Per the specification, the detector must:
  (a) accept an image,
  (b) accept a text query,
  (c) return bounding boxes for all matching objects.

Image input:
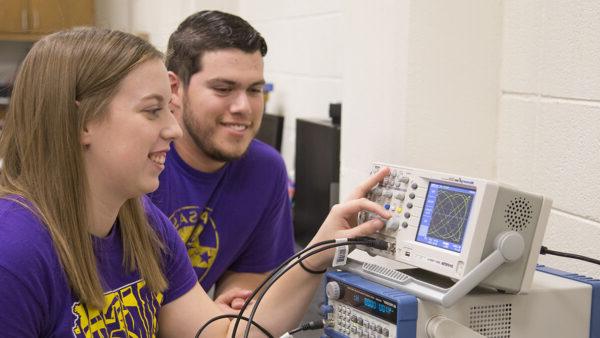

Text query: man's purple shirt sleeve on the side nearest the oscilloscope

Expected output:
[229,159,294,273]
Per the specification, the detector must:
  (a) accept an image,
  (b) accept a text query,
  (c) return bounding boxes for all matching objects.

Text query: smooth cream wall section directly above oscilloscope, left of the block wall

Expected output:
[341,0,502,195]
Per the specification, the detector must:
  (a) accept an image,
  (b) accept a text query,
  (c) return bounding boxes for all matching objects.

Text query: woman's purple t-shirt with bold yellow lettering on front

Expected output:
[0,198,196,337]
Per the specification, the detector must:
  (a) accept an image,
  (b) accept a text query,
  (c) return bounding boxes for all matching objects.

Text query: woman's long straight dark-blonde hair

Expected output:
[0,28,167,309]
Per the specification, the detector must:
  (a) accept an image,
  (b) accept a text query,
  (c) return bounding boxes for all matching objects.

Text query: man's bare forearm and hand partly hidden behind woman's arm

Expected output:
[215,271,270,313]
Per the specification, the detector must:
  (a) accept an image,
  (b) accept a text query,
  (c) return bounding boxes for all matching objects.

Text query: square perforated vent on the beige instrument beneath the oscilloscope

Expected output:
[469,303,512,338]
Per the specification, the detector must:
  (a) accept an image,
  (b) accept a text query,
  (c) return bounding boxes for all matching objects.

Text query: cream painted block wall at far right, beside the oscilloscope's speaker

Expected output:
[497,0,600,278]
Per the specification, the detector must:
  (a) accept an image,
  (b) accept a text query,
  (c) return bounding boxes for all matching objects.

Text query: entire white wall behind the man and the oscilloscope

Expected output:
[98,0,600,278]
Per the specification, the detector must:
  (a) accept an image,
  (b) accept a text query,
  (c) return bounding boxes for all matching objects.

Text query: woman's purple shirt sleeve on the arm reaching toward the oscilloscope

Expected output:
[144,199,198,305]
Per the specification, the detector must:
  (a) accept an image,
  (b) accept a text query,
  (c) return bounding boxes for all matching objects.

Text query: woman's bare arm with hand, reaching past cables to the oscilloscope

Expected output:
[159,168,391,338]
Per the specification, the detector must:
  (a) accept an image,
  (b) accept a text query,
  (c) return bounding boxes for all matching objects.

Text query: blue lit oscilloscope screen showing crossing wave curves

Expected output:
[416,182,475,252]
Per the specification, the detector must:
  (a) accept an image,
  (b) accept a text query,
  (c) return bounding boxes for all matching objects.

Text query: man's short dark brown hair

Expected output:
[166,11,267,86]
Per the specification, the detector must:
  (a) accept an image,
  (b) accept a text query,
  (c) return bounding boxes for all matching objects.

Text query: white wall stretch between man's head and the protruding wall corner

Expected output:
[240,0,346,173]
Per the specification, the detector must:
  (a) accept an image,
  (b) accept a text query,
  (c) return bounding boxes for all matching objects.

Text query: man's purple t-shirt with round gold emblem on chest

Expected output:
[150,140,294,290]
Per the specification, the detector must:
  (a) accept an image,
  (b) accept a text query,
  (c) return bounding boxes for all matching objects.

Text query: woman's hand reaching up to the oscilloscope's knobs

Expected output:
[304,167,392,270]
